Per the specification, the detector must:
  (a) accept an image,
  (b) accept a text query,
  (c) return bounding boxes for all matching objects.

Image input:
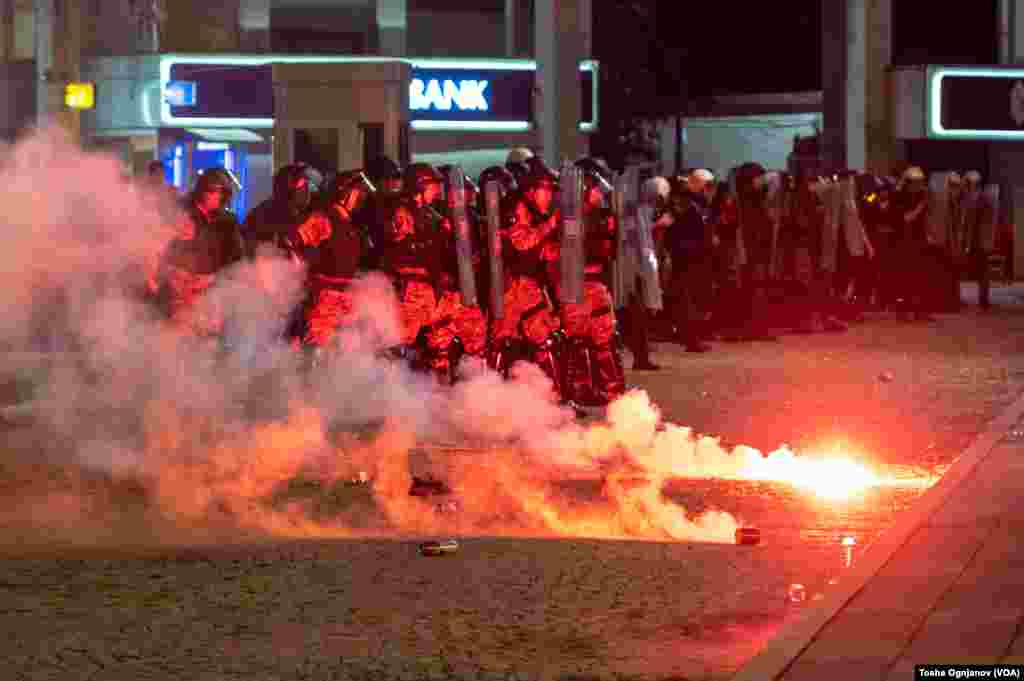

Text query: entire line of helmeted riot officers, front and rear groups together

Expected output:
[148,153,999,406]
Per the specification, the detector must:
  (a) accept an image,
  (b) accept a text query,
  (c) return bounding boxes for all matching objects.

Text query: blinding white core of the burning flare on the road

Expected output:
[741,449,883,501]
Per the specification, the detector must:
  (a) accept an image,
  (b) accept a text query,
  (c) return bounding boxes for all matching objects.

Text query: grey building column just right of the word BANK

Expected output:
[534,0,590,167]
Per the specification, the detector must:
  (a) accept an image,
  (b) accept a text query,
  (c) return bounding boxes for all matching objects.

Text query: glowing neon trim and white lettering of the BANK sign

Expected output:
[160,54,599,132]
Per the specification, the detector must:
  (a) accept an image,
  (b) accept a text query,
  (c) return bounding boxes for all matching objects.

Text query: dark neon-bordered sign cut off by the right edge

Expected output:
[926,66,1024,140]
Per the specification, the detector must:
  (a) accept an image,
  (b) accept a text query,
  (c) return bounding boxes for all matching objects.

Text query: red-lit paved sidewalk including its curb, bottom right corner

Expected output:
[733,387,1024,681]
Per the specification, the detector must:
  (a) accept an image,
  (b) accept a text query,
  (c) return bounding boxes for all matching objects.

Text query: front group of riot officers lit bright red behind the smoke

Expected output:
[147,148,647,407]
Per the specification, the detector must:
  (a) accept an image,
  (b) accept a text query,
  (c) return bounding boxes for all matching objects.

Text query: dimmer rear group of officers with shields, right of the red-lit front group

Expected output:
[629,163,999,352]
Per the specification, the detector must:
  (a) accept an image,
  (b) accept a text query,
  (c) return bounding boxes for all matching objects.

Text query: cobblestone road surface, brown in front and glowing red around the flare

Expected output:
[0,289,1024,681]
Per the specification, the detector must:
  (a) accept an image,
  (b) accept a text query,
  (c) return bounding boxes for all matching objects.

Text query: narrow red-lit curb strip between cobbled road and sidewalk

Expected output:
[731,387,1024,681]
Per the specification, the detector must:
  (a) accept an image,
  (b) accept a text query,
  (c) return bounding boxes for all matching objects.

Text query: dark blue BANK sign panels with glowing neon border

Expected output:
[161,55,598,132]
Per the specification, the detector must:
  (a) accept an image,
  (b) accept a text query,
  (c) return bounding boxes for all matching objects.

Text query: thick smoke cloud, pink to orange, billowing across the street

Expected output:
[0,129,753,541]
